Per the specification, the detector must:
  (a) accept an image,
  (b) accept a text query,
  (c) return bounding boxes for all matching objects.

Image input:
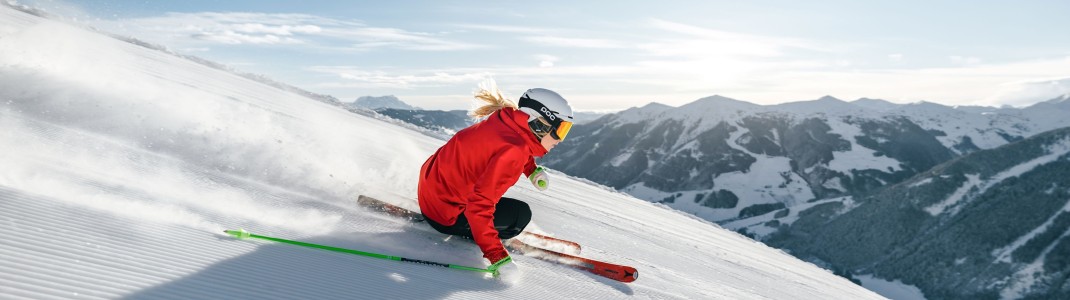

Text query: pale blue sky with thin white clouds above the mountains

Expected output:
[18,0,1070,111]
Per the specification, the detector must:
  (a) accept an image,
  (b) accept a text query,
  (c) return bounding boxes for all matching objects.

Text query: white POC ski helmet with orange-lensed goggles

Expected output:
[518,88,574,140]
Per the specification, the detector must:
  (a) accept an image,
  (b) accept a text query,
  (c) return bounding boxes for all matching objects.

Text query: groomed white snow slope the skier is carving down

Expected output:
[0,5,880,299]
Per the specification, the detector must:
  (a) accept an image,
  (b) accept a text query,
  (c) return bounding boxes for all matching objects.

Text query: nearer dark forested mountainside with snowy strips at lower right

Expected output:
[744,128,1070,299]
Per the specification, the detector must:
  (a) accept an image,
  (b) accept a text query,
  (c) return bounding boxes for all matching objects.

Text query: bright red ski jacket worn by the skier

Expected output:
[417,107,547,263]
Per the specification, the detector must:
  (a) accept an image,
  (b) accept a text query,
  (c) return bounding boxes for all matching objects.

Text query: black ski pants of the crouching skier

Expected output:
[424,197,532,240]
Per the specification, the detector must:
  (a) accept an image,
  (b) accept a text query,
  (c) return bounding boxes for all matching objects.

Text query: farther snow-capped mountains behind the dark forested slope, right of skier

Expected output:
[546,95,1070,222]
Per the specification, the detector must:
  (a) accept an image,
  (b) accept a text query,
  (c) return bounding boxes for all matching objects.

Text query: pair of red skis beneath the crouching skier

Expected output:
[357,195,639,283]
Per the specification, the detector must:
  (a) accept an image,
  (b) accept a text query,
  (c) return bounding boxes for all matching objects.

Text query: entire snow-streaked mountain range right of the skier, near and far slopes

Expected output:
[541,93,1070,299]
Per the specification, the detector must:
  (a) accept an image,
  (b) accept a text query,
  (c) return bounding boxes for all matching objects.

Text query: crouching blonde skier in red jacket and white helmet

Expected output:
[417,83,572,278]
